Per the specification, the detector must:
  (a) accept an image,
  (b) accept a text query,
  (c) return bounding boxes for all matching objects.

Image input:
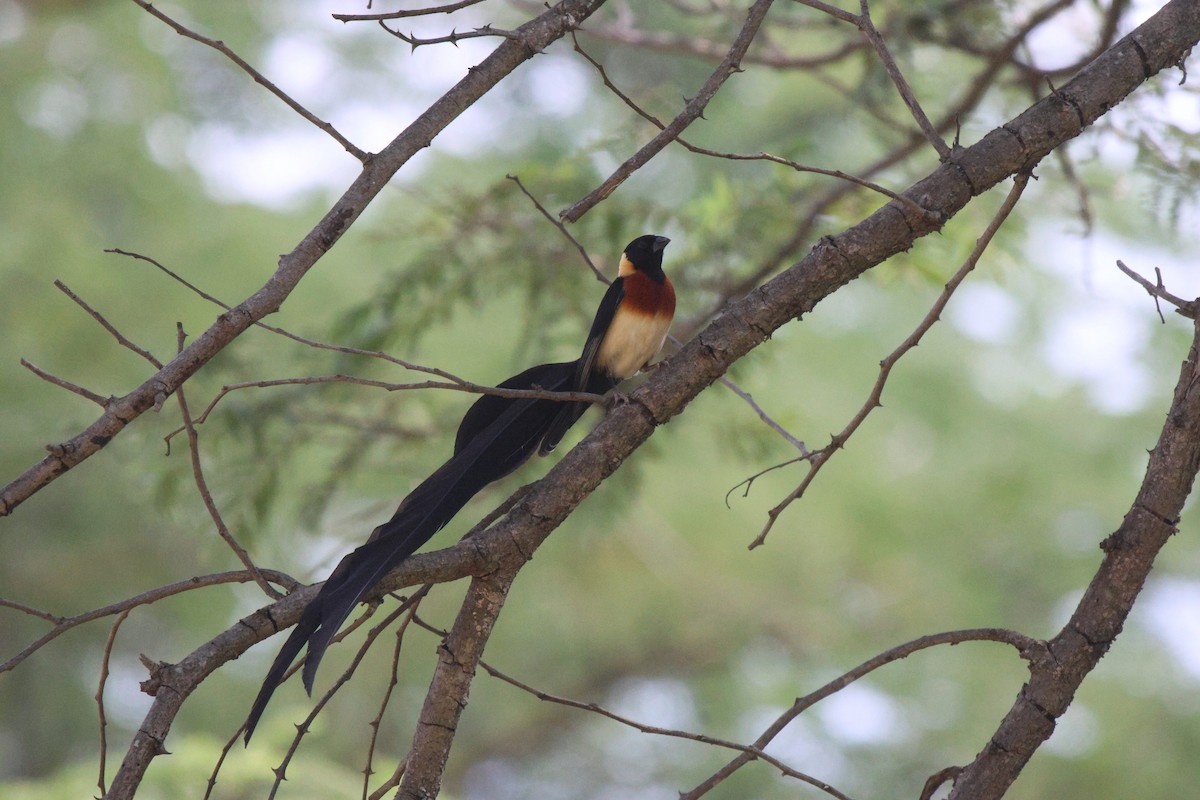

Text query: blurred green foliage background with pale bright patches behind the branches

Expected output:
[0,0,1200,800]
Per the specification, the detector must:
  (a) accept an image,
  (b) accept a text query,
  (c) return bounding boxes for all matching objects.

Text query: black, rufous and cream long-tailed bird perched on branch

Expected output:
[245,235,674,745]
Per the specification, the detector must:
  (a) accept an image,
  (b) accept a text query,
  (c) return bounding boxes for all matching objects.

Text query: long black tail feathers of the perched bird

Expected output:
[246,361,582,744]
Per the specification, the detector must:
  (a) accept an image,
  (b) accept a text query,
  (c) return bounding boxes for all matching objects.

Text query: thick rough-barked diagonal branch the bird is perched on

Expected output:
[87,7,1200,798]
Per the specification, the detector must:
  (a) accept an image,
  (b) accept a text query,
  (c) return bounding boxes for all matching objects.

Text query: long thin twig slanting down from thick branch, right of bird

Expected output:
[750,173,1030,549]
